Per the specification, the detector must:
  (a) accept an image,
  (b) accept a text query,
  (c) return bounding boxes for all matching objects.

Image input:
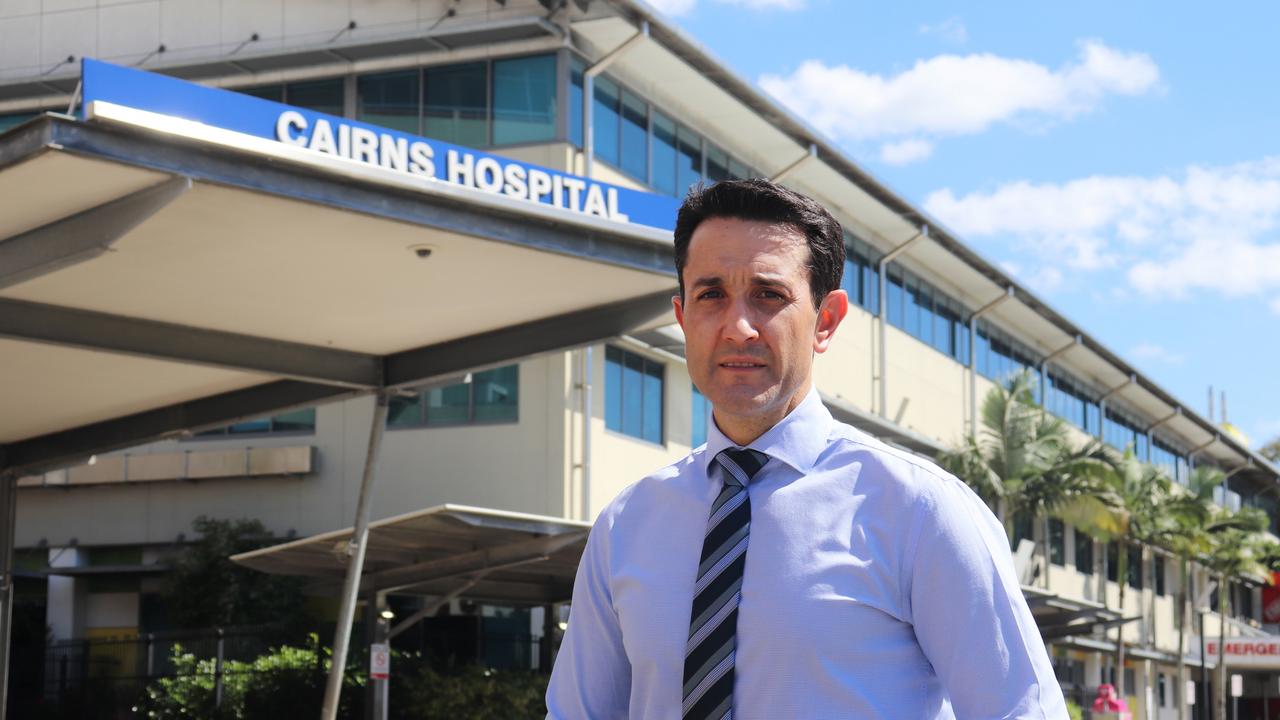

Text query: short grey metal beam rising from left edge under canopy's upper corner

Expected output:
[0,177,191,288]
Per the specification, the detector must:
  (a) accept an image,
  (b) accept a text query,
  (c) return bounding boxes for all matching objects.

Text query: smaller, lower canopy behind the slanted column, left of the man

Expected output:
[232,505,591,605]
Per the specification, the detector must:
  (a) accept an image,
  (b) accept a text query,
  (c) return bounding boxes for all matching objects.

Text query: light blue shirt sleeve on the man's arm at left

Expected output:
[547,510,631,720]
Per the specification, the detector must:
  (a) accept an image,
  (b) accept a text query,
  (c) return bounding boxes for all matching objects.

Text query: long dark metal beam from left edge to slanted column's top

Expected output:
[0,299,381,389]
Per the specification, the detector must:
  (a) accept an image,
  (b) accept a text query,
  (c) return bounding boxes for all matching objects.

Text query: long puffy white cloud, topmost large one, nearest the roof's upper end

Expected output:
[760,41,1160,140]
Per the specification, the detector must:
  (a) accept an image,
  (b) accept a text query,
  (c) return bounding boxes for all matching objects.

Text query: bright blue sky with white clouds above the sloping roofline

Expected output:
[649,0,1280,448]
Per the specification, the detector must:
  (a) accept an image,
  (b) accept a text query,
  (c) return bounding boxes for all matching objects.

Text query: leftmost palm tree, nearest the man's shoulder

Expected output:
[940,372,1107,543]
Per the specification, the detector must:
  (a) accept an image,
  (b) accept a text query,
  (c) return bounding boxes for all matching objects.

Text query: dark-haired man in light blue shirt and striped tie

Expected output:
[547,179,1066,720]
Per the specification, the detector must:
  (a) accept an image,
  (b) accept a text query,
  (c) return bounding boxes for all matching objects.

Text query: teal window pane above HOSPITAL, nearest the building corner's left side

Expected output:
[493,55,556,145]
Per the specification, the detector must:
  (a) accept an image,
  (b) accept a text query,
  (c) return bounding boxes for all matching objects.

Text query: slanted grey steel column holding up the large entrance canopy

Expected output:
[320,392,390,720]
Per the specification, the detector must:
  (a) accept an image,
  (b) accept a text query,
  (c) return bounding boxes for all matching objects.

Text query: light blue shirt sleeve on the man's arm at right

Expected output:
[906,478,1068,720]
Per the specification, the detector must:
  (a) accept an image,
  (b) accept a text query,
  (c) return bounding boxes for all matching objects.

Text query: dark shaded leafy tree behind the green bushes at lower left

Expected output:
[161,515,302,628]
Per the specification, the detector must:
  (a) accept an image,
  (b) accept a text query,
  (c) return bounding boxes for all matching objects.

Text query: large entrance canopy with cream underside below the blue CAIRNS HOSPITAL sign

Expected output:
[0,109,675,477]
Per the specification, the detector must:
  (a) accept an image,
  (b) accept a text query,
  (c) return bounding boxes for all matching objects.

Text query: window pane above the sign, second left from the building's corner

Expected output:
[422,63,489,147]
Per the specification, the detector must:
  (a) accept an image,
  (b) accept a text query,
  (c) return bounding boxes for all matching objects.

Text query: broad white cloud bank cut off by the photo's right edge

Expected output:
[925,156,1280,298]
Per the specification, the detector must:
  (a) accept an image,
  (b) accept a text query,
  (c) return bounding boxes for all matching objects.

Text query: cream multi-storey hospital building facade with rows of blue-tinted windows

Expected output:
[0,0,1280,717]
